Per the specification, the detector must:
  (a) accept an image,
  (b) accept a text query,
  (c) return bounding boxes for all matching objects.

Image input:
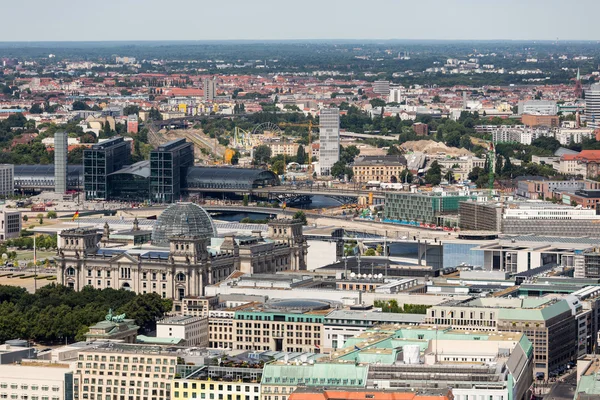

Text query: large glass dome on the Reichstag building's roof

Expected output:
[152,203,217,247]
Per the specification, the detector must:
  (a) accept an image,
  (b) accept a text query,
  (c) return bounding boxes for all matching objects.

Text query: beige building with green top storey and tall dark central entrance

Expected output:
[234,299,331,353]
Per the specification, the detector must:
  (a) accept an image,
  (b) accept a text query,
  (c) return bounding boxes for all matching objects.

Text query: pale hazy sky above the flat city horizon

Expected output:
[0,0,600,41]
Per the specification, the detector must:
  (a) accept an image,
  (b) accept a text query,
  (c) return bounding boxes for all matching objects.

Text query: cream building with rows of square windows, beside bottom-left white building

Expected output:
[72,343,177,400]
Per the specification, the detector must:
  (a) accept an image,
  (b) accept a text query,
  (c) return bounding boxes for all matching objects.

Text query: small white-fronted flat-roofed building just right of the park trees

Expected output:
[156,316,208,347]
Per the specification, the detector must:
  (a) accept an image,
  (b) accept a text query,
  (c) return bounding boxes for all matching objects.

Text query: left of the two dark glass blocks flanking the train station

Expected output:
[83,137,131,200]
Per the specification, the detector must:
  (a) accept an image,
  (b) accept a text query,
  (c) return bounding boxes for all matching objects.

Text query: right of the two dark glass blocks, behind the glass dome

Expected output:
[150,139,194,203]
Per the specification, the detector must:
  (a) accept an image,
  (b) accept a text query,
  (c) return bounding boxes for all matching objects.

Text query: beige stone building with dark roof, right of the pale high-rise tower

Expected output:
[352,156,406,183]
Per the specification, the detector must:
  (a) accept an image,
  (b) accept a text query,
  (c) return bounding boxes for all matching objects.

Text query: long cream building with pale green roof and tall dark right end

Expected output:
[425,298,578,376]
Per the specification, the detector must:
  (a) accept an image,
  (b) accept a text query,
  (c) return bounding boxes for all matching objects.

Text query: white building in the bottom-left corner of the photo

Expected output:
[0,361,73,400]
